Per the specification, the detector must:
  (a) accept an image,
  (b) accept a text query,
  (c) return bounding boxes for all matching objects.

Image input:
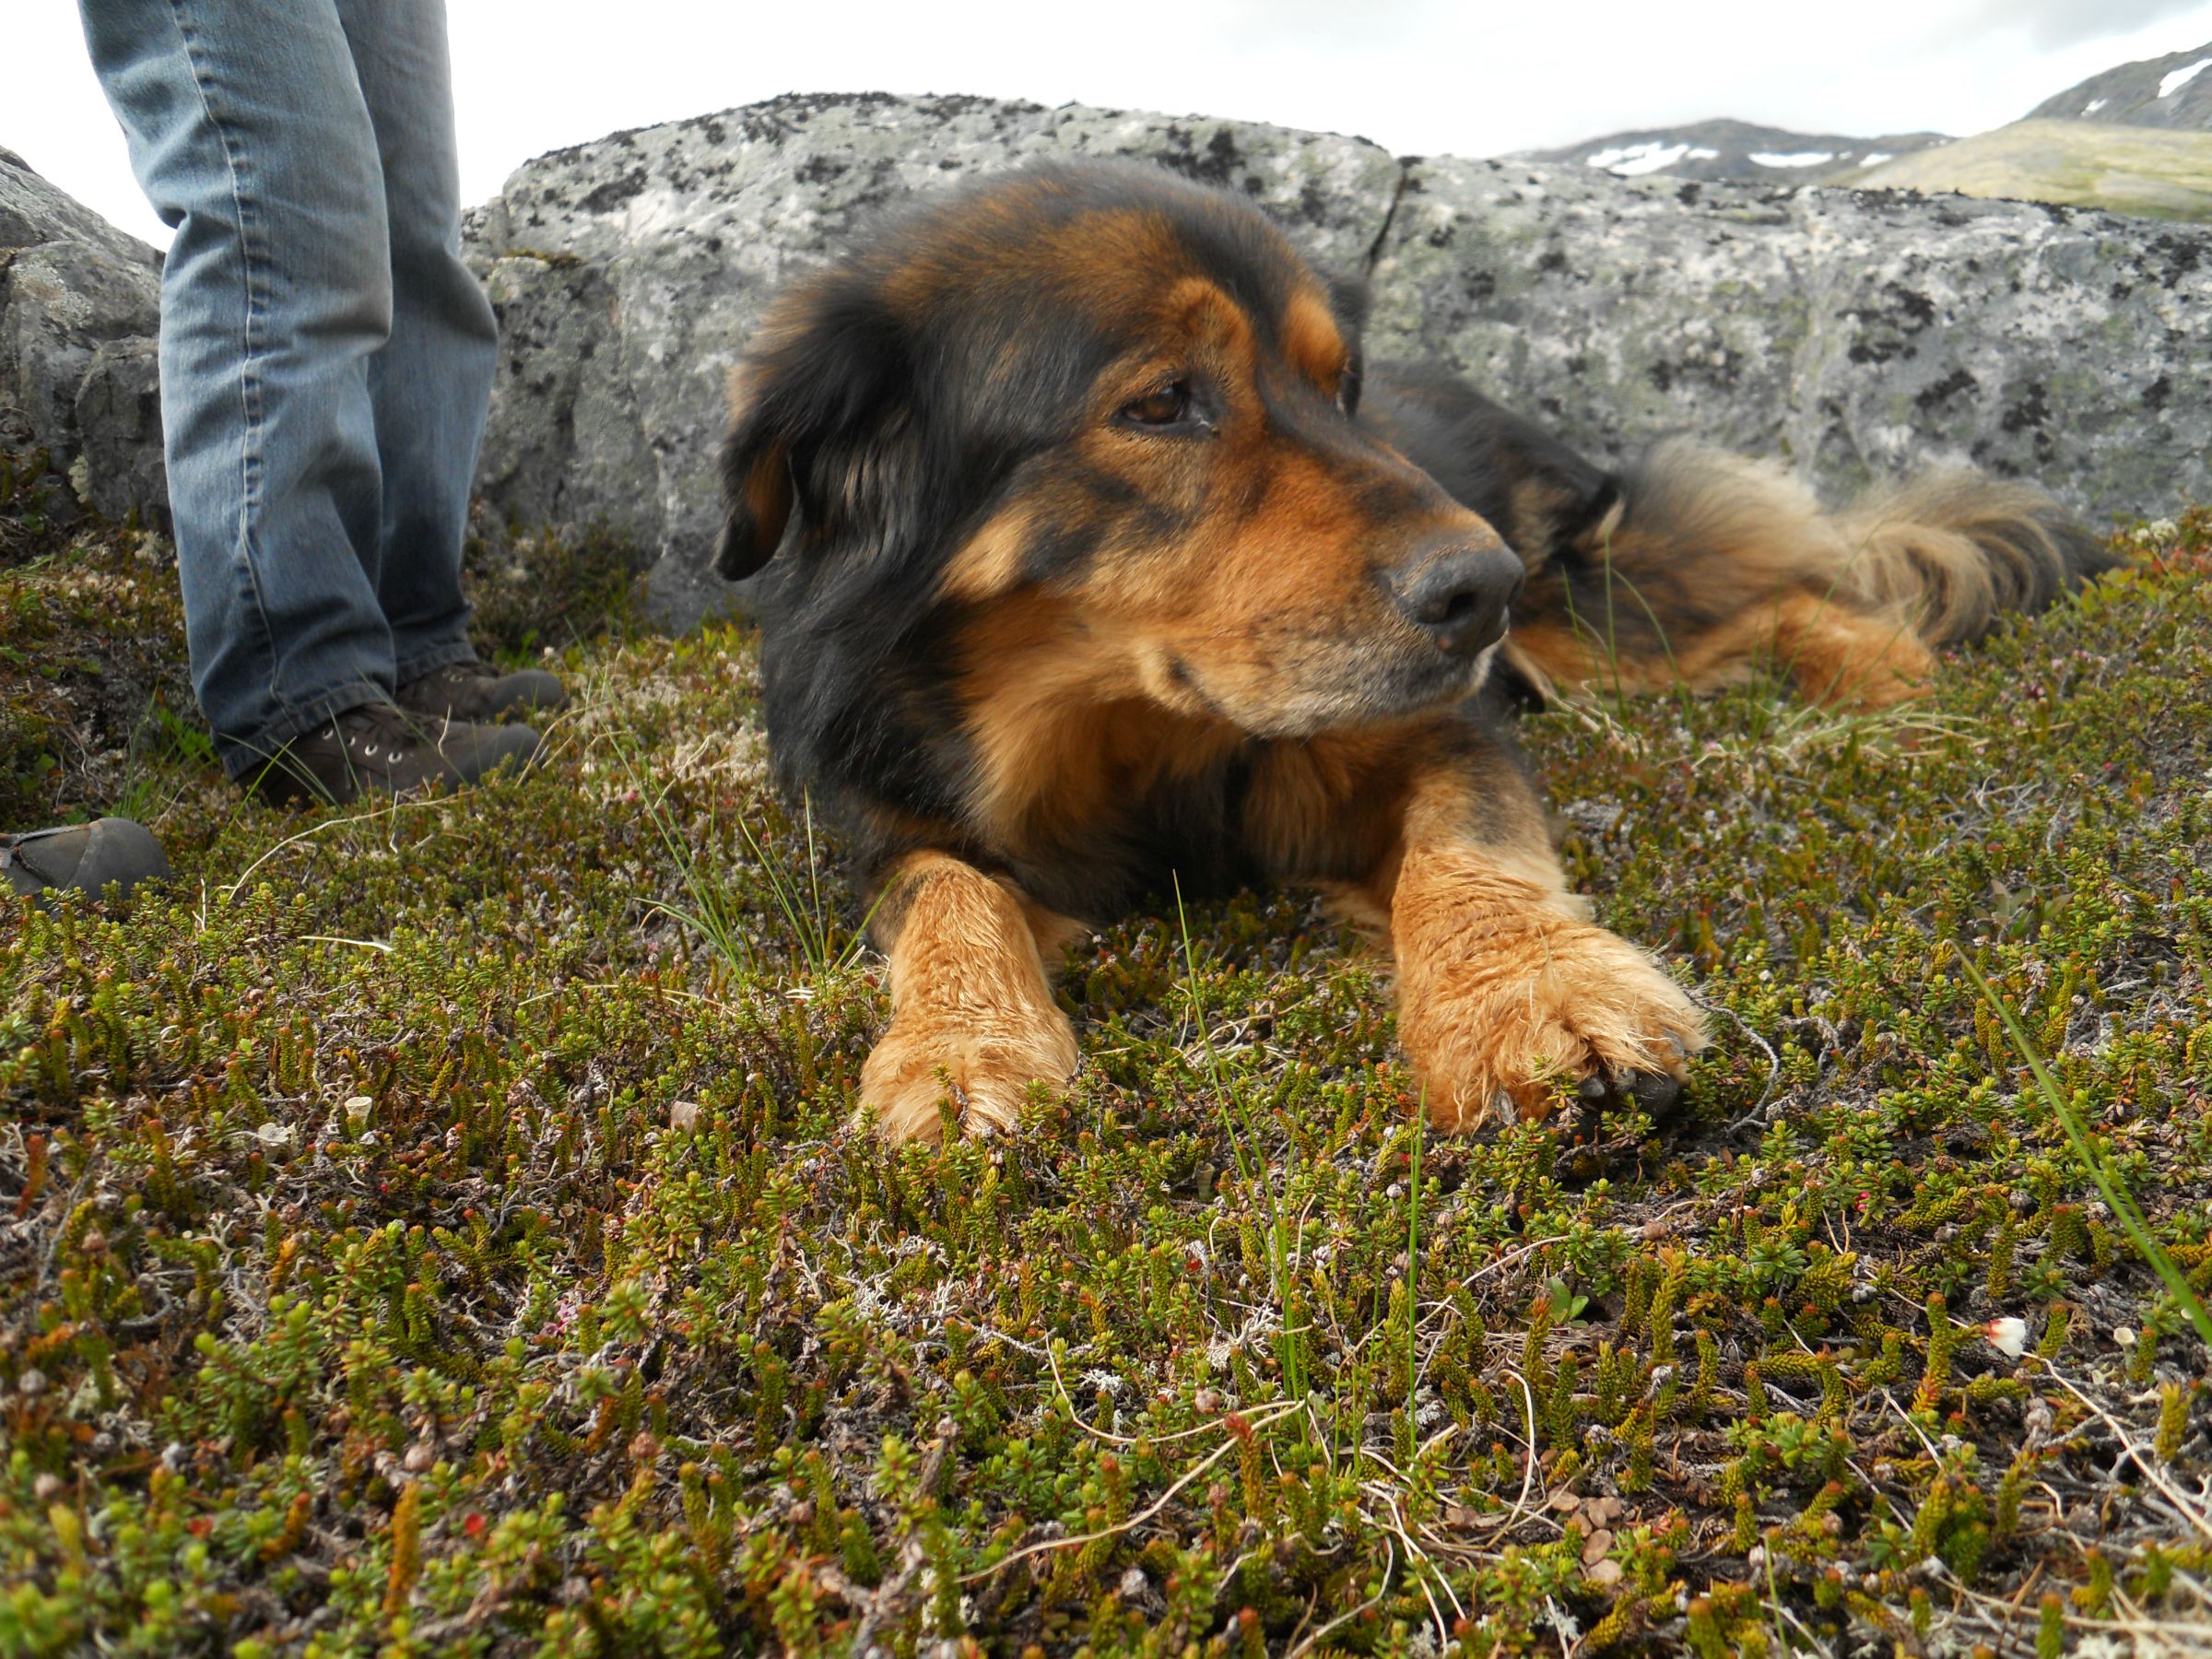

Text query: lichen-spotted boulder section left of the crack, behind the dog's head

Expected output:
[466,95,1400,626]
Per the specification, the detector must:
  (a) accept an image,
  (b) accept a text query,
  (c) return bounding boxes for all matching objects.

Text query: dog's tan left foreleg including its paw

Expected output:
[861,852,1075,1144]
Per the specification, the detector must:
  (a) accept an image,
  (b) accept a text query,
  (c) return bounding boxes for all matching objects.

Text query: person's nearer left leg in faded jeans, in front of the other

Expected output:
[82,0,394,776]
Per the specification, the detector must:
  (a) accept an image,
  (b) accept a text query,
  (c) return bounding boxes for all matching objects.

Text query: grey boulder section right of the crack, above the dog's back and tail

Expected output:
[1373,159,2212,515]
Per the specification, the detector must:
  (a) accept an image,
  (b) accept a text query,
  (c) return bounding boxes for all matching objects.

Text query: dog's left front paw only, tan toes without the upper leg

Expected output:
[861,1011,1075,1146]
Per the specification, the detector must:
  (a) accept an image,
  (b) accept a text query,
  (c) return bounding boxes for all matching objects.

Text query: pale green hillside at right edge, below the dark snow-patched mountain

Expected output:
[1856,120,2212,221]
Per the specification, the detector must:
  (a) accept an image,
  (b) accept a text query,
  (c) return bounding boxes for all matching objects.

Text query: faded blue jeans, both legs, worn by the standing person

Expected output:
[82,0,498,776]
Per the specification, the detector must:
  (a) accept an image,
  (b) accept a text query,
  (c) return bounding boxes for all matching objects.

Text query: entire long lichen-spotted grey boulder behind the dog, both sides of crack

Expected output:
[469,95,2212,626]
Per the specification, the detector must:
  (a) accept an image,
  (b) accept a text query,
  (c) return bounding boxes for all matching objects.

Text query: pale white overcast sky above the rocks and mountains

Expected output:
[13,0,2212,239]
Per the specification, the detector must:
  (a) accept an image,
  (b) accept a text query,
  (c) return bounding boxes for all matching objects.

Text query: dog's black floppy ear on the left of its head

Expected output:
[714,285,931,582]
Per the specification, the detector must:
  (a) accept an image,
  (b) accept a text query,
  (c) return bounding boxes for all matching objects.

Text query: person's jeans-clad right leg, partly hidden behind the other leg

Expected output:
[336,0,500,686]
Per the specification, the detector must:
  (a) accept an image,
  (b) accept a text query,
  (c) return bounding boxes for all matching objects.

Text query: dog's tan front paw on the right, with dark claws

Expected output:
[1398,918,1705,1130]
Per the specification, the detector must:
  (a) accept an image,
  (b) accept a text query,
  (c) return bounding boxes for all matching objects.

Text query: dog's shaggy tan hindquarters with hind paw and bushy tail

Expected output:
[1509,441,2112,706]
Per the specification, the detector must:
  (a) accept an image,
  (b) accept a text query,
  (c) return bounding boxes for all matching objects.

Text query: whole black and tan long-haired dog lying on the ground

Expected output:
[719,164,2097,1139]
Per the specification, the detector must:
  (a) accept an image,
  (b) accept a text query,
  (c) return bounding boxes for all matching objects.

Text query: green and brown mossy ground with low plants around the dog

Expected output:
[0,471,2212,1659]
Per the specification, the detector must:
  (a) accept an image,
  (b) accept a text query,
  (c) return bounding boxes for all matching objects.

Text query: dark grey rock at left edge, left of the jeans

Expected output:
[0,150,168,518]
